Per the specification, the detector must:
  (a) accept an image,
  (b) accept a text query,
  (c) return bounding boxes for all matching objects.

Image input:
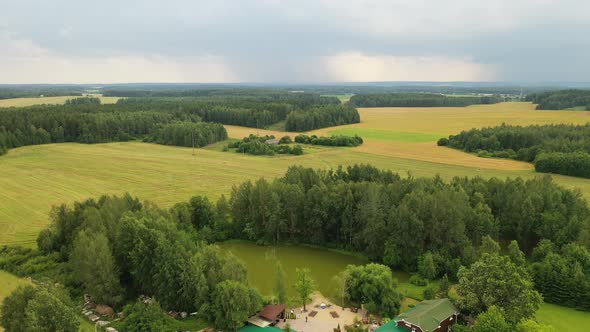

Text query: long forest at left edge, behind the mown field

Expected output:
[0,104,208,155]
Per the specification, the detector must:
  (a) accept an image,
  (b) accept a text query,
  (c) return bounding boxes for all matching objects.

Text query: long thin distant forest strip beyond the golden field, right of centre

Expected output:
[349,93,504,107]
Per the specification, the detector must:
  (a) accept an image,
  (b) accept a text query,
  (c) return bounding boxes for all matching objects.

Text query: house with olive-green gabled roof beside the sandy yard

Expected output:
[375,299,459,332]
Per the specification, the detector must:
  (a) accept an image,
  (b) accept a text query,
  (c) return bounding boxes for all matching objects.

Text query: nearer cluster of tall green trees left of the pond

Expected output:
[0,195,262,331]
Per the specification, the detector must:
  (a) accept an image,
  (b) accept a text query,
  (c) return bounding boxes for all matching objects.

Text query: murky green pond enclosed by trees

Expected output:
[218,241,368,298]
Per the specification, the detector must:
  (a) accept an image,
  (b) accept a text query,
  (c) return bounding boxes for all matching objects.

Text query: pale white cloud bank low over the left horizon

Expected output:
[0,34,238,83]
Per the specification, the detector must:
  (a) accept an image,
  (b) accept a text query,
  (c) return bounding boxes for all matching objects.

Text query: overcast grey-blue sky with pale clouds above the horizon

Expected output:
[0,0,590,83]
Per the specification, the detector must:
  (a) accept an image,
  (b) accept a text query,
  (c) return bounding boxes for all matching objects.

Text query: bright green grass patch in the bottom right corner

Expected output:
[537,303,590,332]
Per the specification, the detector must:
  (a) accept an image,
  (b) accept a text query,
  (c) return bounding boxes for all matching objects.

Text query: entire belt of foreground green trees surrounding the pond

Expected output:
[0,165,590,330]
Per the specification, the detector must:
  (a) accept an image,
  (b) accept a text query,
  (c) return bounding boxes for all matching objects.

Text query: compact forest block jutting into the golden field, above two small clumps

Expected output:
[285,105,361,132]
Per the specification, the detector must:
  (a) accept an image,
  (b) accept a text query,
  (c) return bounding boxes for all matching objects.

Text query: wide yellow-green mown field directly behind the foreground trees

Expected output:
[0,142,590,246]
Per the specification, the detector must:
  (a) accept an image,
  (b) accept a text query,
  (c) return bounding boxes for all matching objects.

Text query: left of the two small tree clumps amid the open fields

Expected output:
[227,134,303,156]
